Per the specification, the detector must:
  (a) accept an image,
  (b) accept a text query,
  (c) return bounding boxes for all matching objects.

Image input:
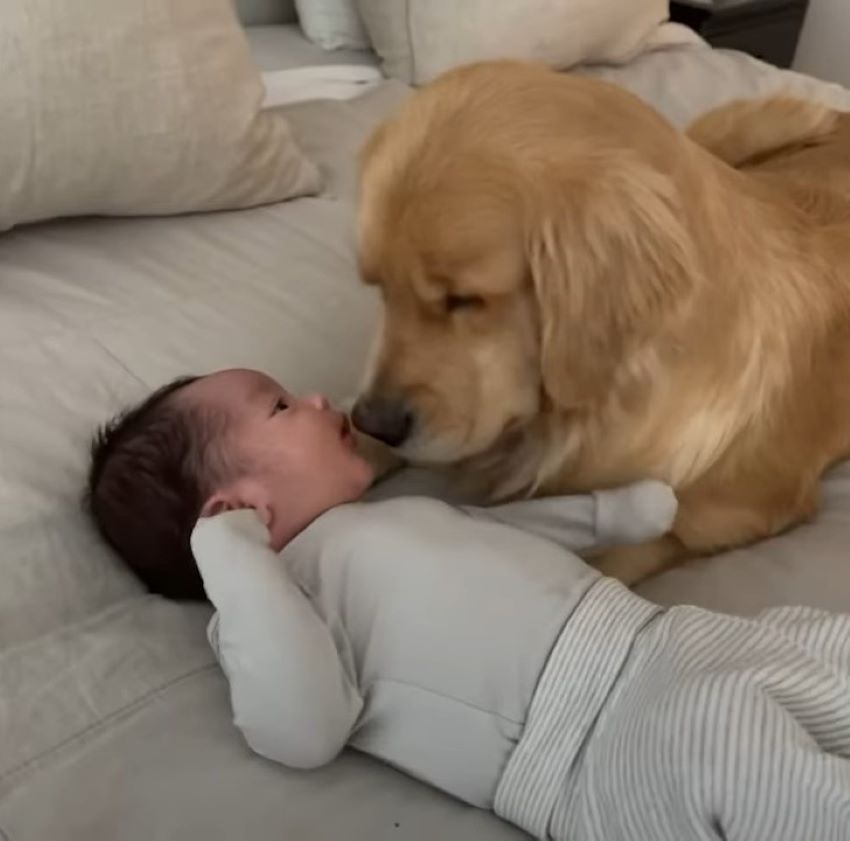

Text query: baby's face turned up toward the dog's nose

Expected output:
[184,368,373,549]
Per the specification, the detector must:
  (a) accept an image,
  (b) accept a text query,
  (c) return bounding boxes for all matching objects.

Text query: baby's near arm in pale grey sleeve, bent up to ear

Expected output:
[192,510,363,768]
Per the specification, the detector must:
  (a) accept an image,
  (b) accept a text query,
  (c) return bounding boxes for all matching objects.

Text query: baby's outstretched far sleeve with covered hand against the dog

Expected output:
[463,480,678,552]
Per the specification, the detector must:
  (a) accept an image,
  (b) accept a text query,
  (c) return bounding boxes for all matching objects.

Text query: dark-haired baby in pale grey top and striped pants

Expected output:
[89,370,850,841]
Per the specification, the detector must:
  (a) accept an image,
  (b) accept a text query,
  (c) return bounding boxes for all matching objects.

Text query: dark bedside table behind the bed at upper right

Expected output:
[670,0,809,67]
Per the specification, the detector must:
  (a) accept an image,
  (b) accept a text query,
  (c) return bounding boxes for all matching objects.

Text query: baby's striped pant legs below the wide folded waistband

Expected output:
[554,608,850,841]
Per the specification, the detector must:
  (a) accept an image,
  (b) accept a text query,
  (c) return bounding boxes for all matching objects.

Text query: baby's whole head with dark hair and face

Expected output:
[88,369,372,599]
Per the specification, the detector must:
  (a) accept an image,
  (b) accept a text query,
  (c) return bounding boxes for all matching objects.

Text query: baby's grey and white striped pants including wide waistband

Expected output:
[497,581,850,841]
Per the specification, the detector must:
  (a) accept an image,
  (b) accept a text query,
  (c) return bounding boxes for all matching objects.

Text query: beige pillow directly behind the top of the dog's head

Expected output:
[358,0,668,84]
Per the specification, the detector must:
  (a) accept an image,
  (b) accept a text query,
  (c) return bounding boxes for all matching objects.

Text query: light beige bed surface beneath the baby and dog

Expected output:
[0,28,850,841]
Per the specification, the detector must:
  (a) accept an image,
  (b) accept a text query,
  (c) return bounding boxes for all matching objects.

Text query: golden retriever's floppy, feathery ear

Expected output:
[525,155,699,409]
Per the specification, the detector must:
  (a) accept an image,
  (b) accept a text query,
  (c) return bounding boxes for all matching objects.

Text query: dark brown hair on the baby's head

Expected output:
[86,377,226,600]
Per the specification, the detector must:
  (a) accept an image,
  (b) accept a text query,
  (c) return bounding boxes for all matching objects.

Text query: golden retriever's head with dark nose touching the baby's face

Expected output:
[355,62,696,486]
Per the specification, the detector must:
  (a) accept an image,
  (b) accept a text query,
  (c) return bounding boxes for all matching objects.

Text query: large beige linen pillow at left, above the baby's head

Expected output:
[0,0,320,230]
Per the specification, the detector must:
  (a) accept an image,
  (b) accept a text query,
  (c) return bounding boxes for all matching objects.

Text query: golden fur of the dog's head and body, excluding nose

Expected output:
[359,62,850,583]
